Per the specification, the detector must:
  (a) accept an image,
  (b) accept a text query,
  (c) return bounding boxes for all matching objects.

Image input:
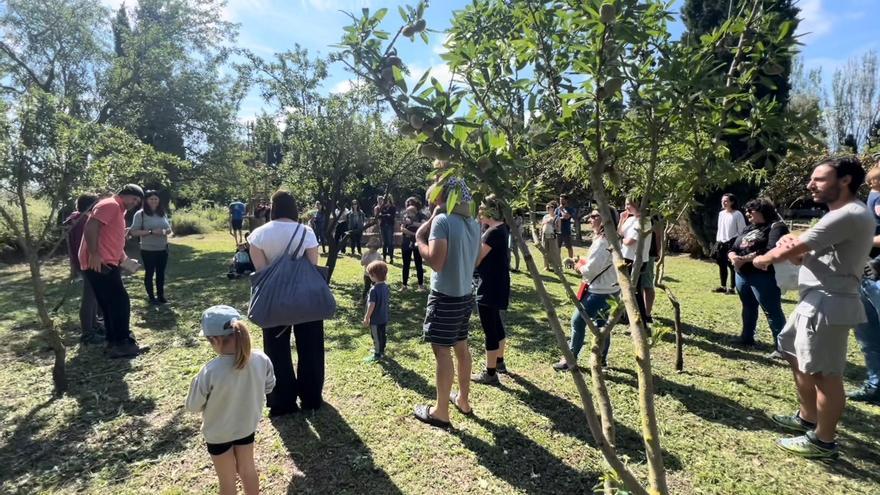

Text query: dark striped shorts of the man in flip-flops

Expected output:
[422,290,474,347]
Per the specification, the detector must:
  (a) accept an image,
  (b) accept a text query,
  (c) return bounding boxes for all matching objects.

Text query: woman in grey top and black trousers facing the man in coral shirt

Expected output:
[129,190,171,304]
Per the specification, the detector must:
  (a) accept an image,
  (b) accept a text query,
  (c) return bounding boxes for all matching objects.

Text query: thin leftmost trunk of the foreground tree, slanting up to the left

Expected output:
[504,208,648,495]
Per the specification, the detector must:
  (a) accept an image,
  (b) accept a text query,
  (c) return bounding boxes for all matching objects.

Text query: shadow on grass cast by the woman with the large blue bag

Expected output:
[272,402,403,495]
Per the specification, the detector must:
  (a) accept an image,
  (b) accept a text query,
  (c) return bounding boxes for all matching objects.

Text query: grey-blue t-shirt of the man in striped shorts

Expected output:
[428,213,480,297]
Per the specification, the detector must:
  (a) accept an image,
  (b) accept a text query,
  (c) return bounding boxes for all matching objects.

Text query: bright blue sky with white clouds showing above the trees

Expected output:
[104,0,880,120]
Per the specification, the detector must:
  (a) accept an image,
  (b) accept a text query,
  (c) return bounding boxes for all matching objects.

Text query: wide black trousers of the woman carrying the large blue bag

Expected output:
[263,321,324,412]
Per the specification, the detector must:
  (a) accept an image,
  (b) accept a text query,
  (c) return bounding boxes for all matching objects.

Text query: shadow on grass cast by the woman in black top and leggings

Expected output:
[508,374,682,471]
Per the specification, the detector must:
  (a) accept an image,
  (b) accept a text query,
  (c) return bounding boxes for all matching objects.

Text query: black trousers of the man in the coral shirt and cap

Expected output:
[83,267,134,345]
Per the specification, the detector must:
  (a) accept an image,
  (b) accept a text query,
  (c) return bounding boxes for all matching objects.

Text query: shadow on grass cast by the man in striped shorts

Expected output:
[453,416,600,493]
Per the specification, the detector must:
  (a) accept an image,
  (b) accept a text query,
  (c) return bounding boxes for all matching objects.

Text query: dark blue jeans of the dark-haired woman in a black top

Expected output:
[736,272,785,348]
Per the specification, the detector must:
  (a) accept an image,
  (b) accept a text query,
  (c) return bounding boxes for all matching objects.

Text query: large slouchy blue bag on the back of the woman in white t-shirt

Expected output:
[248,224,336,328]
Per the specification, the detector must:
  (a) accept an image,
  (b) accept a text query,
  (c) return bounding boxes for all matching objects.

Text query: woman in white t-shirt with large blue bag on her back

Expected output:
[248,191,336,417]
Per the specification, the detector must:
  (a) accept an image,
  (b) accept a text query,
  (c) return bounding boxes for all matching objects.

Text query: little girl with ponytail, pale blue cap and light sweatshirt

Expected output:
[186,305,275,495]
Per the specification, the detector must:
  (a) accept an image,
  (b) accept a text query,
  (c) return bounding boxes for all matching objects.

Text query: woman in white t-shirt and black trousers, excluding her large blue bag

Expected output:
[248,191,324,417]
